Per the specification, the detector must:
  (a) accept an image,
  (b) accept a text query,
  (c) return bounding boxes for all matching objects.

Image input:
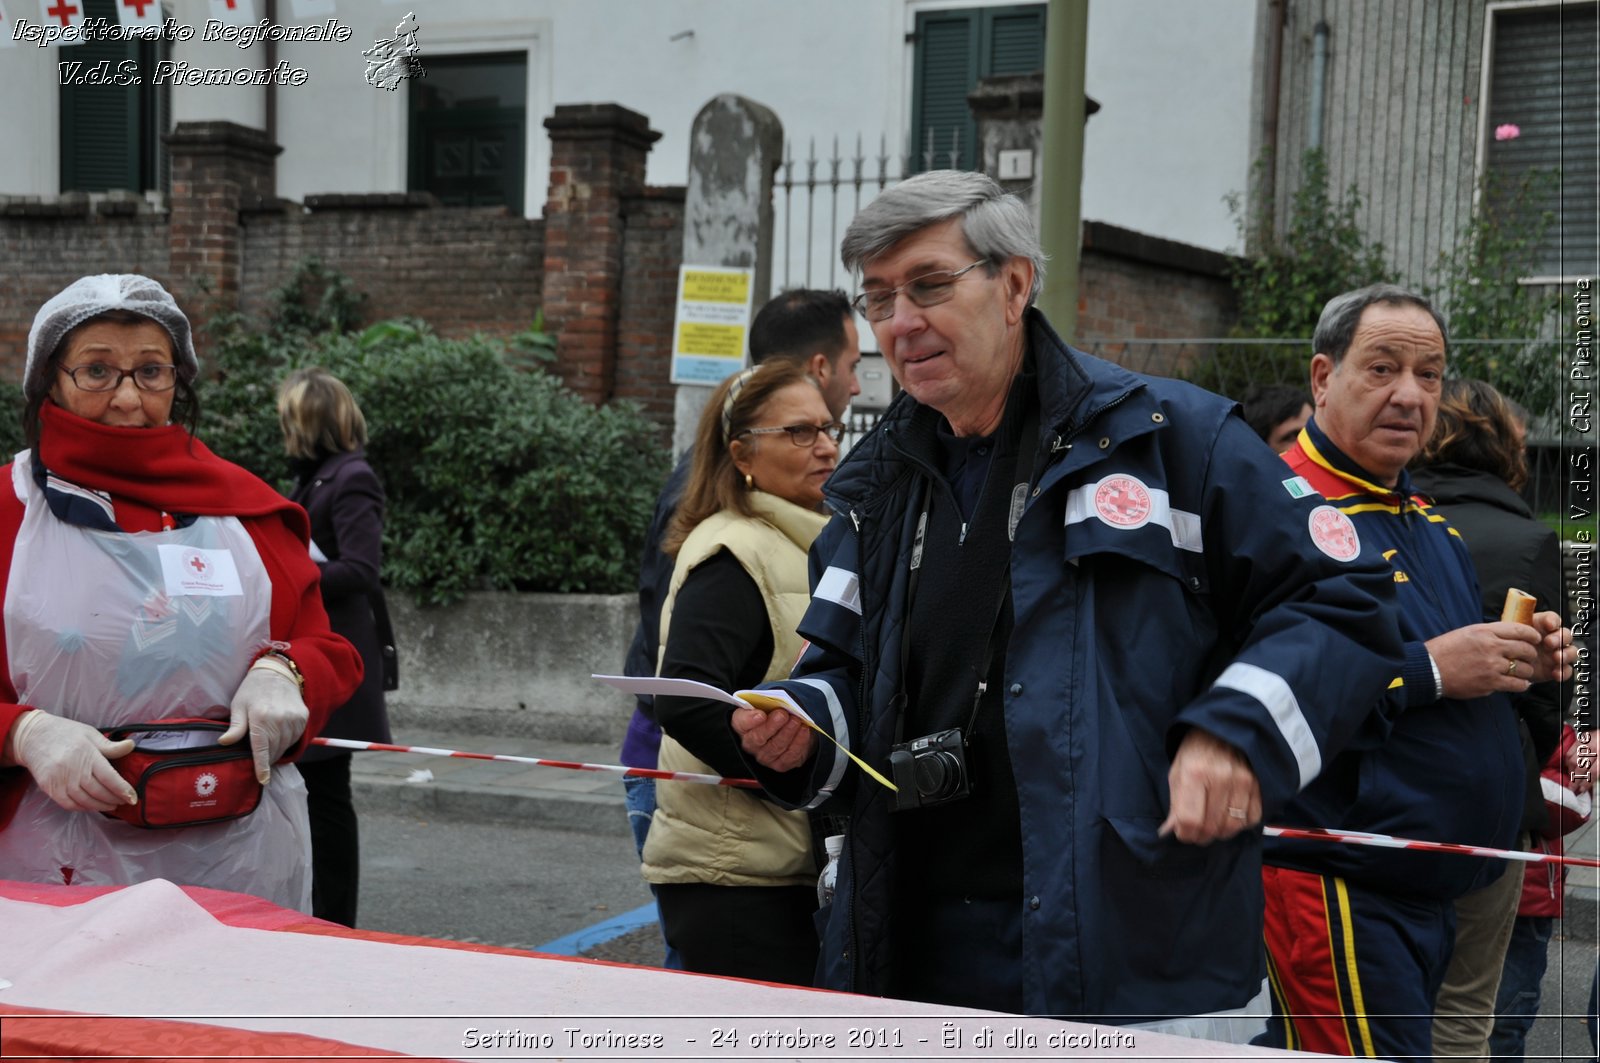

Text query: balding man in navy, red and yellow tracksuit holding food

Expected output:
[1262,285,1576,1058]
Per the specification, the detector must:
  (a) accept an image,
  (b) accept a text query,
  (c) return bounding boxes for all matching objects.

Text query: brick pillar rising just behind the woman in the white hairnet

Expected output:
[165,122,283,317]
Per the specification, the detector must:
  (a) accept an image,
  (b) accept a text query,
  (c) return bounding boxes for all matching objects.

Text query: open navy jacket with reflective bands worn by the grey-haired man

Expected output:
[752,311,1400,1021]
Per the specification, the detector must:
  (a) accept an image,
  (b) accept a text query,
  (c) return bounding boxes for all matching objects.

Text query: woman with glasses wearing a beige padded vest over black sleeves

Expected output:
[643,362,843,985]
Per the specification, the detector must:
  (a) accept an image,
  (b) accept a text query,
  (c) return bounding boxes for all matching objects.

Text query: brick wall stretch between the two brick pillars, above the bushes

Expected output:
[240,194,544,336]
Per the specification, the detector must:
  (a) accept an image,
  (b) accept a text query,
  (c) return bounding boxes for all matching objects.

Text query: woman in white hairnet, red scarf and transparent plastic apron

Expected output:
[0,274,362,911]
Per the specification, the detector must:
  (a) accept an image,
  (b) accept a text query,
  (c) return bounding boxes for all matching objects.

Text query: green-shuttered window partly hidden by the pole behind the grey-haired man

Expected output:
[910,3,1045,171]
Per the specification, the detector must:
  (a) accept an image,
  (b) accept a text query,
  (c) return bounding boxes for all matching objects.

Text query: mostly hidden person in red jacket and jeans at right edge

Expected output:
[1490,725,1594,1060]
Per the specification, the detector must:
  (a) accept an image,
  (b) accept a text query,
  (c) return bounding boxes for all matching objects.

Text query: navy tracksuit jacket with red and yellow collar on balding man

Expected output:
[1267,418,1523,900]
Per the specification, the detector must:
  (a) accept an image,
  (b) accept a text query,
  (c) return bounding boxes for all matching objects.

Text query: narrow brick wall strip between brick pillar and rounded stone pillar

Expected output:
[613,187,683,434]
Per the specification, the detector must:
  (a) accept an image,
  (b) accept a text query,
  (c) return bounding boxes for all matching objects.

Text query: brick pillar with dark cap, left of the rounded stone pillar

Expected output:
[544,104,661,403]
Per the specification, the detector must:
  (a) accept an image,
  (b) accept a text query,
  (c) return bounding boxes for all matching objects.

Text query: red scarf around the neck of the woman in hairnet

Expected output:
[38,400,310,540]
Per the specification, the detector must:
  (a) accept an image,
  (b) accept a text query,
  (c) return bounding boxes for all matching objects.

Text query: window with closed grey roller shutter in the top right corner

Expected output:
[1482,3,1600,277]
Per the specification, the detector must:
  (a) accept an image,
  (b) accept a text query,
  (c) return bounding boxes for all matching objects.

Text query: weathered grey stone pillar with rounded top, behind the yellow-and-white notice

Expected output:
[672,93,784,455]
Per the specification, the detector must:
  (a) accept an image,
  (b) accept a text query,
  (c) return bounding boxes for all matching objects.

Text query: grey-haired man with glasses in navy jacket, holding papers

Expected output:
[733,171,1400,1041]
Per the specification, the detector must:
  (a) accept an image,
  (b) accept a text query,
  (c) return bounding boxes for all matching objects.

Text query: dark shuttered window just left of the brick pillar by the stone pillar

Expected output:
[410,51,528,215]
